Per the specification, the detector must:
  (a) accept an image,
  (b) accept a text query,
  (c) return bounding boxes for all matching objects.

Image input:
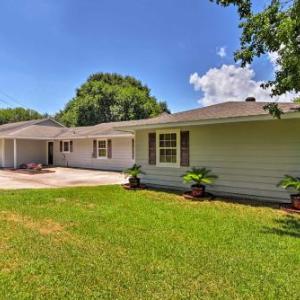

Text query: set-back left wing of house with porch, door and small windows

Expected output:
[0,119,134,171]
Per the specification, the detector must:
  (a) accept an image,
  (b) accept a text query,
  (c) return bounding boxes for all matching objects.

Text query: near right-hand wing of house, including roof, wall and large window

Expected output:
[117,101,300,202]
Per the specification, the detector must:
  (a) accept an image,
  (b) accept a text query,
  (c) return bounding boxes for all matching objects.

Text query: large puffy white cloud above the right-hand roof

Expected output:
[190,65,296,106]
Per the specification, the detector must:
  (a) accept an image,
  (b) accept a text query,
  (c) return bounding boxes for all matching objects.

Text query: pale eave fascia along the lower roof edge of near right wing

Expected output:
[114,111,300,132]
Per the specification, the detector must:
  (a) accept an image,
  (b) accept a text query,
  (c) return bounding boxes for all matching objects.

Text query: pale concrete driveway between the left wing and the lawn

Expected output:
[0,167,126,189]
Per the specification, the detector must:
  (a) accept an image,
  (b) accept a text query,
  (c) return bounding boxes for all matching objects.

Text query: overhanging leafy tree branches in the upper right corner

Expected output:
[210,0,300,95]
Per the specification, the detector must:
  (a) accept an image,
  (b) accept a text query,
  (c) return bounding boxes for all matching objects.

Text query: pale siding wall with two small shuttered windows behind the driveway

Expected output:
[54,137,134,171]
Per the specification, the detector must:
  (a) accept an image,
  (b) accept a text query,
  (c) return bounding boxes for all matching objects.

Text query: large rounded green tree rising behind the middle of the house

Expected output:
[56,73,168,126]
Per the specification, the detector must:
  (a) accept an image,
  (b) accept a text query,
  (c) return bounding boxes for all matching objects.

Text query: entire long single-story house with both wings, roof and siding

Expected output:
[0,102,300,202]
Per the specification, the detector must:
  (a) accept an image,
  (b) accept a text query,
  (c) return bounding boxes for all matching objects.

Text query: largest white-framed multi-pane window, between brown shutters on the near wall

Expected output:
[157,131,180,166]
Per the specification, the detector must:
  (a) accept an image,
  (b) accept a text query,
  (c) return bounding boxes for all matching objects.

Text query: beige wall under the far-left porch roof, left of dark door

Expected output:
[17,139,47,167]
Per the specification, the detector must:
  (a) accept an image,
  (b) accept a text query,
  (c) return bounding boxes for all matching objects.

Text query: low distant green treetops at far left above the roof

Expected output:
[0,107,46,125]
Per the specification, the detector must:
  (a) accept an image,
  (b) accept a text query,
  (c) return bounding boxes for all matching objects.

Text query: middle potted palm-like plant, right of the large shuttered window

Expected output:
[183,168,218,198]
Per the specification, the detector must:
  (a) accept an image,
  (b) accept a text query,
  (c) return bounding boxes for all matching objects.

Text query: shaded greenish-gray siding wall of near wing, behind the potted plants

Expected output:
[136,120,300,202]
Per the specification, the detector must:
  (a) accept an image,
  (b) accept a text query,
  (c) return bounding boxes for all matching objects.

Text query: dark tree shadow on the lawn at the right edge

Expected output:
[263,215,300,238]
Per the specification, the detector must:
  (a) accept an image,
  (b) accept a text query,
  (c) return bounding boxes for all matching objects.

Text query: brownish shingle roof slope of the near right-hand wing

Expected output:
[113,102,300,129]
